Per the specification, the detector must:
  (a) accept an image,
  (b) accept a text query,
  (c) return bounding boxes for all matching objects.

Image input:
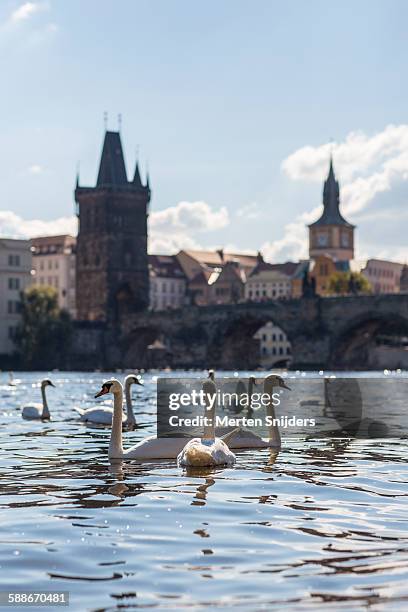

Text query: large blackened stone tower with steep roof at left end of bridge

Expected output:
[75,131,150,323]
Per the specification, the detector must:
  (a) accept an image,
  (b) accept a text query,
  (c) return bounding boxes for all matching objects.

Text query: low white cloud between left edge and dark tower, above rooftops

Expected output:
[0,210,77,238]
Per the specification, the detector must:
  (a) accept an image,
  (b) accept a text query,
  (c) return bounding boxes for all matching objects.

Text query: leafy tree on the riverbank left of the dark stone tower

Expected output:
[15,287,72,370]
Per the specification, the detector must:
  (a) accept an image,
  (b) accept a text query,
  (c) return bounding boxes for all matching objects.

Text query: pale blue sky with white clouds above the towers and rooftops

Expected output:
[0,0,408,261]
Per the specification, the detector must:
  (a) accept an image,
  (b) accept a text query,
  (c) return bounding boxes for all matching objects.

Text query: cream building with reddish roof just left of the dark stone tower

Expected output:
[31,234,76,319]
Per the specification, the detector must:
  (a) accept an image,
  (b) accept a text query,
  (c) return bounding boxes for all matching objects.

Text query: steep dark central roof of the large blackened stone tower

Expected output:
[96,131,127,187]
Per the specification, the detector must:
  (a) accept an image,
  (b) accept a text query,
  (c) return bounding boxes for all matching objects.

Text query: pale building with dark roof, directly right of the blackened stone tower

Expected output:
[149,255,187,310]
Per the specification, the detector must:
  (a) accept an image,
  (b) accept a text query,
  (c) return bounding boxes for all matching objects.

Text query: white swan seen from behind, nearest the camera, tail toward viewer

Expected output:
[177,371,236,467]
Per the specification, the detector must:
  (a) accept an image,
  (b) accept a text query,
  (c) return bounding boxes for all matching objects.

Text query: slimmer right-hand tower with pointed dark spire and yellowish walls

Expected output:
[309,158,355,261]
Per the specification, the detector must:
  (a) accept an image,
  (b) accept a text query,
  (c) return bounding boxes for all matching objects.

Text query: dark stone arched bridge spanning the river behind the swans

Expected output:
[115,294,408,370]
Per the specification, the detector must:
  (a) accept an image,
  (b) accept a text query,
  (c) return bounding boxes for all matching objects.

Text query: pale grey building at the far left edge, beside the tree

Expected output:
[0,238,32,355]
